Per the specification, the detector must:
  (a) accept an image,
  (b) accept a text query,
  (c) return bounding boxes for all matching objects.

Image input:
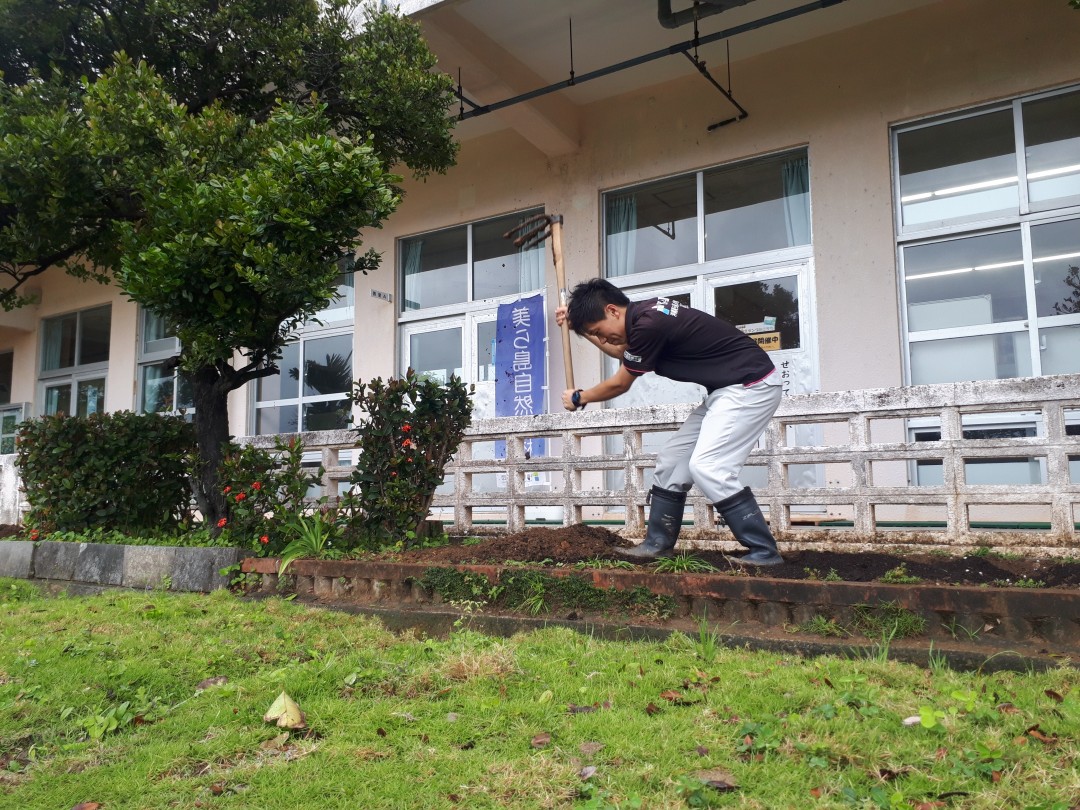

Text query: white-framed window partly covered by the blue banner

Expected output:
[397,208,546,416]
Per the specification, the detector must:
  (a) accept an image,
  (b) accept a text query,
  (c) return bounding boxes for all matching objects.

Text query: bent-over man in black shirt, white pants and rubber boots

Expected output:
[555,279,784,566]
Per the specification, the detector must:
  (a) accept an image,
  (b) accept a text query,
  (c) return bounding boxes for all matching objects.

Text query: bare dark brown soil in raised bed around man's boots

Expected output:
[393,524,1080,588]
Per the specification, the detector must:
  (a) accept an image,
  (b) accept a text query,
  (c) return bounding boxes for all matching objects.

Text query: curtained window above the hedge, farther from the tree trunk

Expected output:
[39,306,112,416]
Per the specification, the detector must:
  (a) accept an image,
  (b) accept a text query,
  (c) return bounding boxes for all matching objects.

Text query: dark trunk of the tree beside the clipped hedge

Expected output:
[191,367,230,527]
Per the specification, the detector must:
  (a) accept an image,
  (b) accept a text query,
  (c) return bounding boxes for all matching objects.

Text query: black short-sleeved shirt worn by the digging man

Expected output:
[622,298,775,392]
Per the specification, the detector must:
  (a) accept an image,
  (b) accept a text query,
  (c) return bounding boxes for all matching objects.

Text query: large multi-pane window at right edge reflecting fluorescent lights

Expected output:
[894,90,1080,384]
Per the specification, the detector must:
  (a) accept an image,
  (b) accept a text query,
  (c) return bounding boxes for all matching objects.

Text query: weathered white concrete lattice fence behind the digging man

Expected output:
[0,375,1080,555]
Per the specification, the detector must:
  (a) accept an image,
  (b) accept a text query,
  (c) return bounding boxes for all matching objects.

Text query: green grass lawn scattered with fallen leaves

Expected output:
[0,580,1080,810]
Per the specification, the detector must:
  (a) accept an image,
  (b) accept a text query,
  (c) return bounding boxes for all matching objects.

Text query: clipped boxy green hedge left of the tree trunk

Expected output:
[15,410,195,534]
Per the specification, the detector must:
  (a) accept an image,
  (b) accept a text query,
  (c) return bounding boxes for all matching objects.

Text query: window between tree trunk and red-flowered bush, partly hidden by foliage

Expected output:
[255,273,354,434]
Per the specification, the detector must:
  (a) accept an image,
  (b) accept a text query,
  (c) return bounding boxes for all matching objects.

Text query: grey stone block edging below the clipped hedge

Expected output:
[0,540,243,592]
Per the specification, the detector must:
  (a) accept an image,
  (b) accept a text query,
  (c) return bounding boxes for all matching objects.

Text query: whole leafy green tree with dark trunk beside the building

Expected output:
[0,0,456,522]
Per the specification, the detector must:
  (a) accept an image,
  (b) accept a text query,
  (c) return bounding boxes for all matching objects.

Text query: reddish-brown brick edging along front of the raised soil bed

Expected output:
[241,557,1080,659]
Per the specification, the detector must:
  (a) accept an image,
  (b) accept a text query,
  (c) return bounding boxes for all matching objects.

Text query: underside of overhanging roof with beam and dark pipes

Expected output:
[401,0,942,156]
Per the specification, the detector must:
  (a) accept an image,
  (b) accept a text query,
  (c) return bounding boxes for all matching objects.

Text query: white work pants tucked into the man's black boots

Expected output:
[652,372,783,503]
